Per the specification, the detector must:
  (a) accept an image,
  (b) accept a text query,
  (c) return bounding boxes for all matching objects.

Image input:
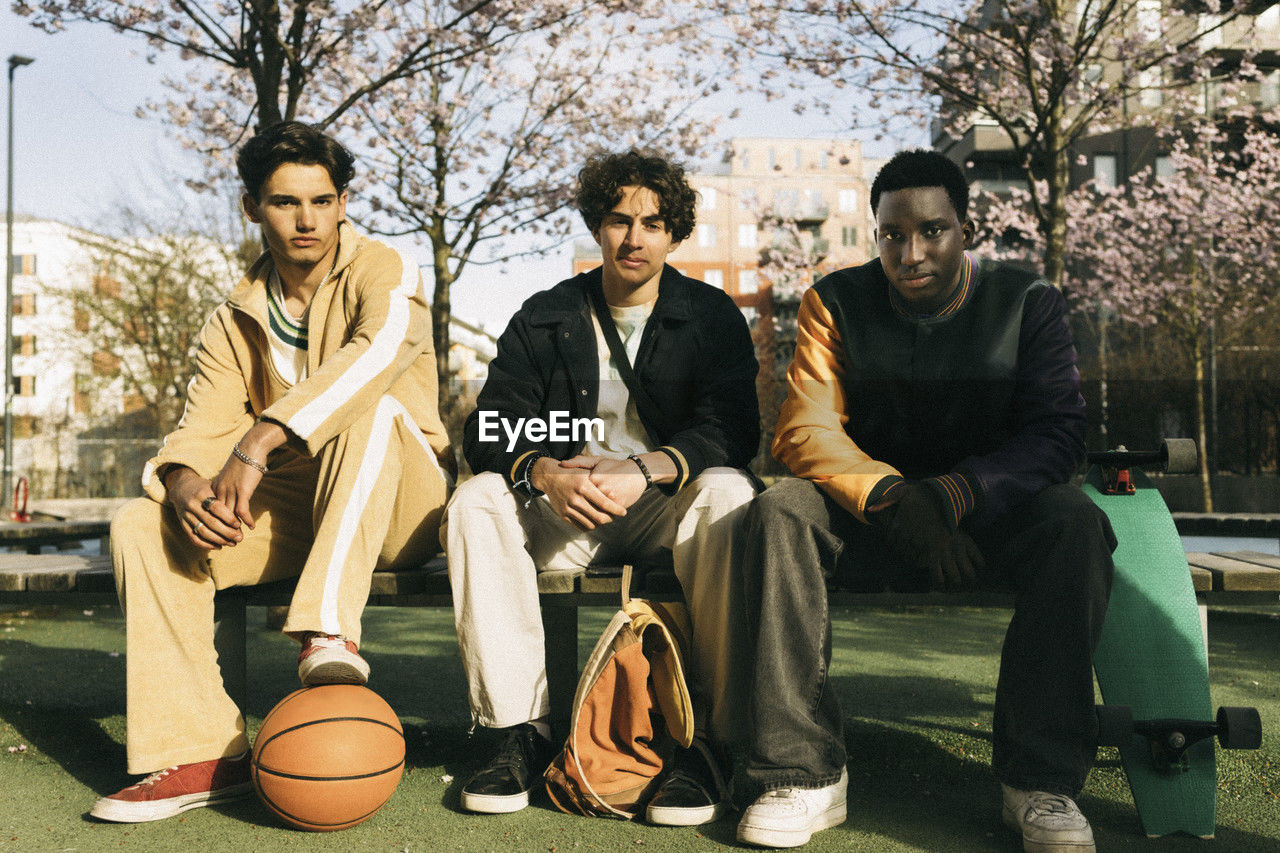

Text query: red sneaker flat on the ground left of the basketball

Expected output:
[90,752,253,824]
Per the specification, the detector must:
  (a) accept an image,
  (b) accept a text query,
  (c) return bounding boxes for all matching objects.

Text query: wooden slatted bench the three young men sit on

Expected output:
[0,529,1280,724]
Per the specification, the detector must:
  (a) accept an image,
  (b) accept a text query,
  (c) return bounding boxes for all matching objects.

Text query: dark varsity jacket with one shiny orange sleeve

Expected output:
[773,252,1085,525]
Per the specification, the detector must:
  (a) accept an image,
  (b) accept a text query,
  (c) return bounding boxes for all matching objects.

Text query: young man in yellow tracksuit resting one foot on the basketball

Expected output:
[92,122,452,822]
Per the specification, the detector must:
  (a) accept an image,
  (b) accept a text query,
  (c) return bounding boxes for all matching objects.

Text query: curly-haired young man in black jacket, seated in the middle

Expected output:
[444,151,759,825]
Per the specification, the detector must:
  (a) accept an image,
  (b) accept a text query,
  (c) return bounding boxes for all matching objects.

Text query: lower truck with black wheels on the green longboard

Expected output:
[1097,704,1262,774]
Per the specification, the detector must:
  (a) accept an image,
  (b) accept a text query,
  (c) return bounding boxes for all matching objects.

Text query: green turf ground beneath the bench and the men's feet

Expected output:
[0,607,1280,853]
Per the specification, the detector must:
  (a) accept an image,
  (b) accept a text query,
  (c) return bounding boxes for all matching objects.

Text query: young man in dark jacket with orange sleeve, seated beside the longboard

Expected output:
[737,151,1115,853]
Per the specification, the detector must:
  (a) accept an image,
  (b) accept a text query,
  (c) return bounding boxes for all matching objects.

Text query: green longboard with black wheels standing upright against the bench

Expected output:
[1084,439,1261,838]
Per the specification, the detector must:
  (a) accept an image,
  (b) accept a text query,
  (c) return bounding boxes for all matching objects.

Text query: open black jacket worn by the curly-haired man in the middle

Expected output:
[462,266,760,491]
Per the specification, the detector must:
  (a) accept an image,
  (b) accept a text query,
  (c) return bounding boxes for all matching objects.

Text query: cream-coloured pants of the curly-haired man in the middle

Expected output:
[443,467,755,742]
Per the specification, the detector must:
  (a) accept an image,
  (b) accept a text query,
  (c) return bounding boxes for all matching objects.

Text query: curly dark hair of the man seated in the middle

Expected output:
[573,149,698,242]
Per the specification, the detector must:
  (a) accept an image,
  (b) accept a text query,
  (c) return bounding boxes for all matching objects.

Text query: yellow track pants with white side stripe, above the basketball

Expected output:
[111,397,448,774]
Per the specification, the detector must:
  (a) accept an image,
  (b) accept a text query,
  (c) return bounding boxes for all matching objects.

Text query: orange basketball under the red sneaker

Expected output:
[252,684,404,833]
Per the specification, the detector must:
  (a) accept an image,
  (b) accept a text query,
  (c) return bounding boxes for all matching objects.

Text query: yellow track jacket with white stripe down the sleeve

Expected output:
[142,223,454,502]
